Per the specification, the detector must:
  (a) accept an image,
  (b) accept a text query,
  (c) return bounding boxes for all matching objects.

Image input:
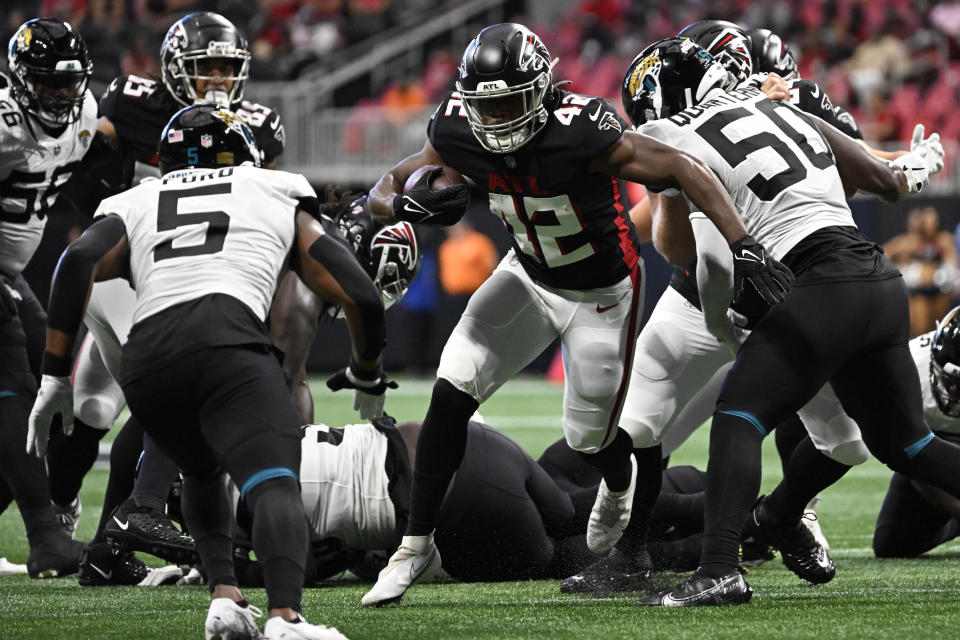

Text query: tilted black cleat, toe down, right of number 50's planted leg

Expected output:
[750,496,837,584]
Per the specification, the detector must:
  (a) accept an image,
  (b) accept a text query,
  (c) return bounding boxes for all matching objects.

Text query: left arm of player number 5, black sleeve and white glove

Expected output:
[27,216,130,458]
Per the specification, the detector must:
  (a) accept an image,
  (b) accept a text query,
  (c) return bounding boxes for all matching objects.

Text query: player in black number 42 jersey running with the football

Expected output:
[363,23,790,605]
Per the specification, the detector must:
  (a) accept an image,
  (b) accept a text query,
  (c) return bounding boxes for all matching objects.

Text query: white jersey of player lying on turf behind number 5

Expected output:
[300,424,397,550]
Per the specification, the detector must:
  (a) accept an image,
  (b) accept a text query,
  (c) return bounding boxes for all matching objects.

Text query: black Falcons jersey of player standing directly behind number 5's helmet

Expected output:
[100,76,285,187]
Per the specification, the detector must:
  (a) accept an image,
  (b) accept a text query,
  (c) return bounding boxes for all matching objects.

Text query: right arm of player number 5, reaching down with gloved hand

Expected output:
[292,211,396,419]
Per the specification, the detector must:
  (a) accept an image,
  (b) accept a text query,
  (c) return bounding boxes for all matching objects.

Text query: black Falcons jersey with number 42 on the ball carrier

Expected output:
[427,91,639,290]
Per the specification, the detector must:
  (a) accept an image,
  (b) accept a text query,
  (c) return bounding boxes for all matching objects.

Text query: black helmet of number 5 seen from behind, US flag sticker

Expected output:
[157,103,260,174]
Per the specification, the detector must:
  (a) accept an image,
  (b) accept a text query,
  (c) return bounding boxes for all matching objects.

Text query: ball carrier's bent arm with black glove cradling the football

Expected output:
[367,140,468,226]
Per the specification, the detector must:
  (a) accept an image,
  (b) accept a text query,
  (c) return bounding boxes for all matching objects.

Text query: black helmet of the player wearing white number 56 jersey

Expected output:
[7,18,93,127]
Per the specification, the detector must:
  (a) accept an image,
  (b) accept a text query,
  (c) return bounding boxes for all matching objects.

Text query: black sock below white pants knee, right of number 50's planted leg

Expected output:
[767,436,850,522]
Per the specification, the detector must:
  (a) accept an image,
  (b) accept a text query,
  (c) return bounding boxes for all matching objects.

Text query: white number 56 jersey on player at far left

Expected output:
[0,87,97,276]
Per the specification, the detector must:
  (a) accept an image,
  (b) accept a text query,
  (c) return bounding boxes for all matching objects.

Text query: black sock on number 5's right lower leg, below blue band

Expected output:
[248,477,309,611]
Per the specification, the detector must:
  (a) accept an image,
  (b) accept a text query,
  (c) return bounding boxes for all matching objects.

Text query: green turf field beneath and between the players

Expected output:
[0,380,960,640]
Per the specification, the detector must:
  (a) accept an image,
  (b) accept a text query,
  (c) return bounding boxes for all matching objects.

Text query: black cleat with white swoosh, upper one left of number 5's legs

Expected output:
[103,499,197,564]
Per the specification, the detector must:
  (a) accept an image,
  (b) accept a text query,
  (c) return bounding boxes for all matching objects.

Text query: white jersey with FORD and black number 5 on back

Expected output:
[103,165,316,324]
